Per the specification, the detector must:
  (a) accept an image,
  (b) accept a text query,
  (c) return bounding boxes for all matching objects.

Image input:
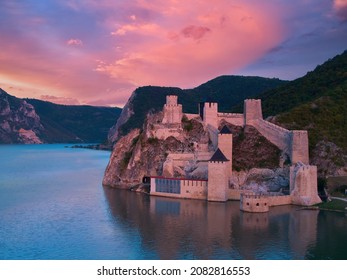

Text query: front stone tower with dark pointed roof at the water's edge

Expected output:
[207,149,229,202]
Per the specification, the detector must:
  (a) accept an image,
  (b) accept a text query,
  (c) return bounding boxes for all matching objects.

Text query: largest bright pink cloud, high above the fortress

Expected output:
[97,0,284,87]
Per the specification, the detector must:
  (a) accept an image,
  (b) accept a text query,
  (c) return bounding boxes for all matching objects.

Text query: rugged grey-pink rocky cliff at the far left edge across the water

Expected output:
[0,89,44,144]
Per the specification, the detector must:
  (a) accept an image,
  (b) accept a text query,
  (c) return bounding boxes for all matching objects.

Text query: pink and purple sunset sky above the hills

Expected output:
[0,0,347,107]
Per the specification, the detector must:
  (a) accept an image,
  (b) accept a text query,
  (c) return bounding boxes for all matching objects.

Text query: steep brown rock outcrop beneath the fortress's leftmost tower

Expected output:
[103,113,209,188]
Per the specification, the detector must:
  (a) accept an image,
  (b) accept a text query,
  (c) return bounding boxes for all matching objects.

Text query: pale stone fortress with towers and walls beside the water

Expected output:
[146,95,321,212]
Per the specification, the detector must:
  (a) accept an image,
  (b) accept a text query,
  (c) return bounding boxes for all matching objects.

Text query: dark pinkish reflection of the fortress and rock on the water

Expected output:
[104,188,346,259]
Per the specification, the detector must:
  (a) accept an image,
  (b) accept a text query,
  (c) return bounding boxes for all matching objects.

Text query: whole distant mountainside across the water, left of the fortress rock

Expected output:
[0,89,121,144]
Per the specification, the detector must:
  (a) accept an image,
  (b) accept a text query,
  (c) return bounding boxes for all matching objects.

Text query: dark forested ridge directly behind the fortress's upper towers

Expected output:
[109,76,287,142]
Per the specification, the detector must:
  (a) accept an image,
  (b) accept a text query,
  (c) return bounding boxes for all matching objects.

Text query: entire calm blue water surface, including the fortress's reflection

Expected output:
[0,145,347,259]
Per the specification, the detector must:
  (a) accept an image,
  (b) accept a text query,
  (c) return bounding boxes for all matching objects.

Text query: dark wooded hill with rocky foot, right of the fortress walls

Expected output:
[233,51,347,176]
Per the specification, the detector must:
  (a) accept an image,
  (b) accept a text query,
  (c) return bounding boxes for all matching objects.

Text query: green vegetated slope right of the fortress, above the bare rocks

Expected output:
[262,51,347,152]
